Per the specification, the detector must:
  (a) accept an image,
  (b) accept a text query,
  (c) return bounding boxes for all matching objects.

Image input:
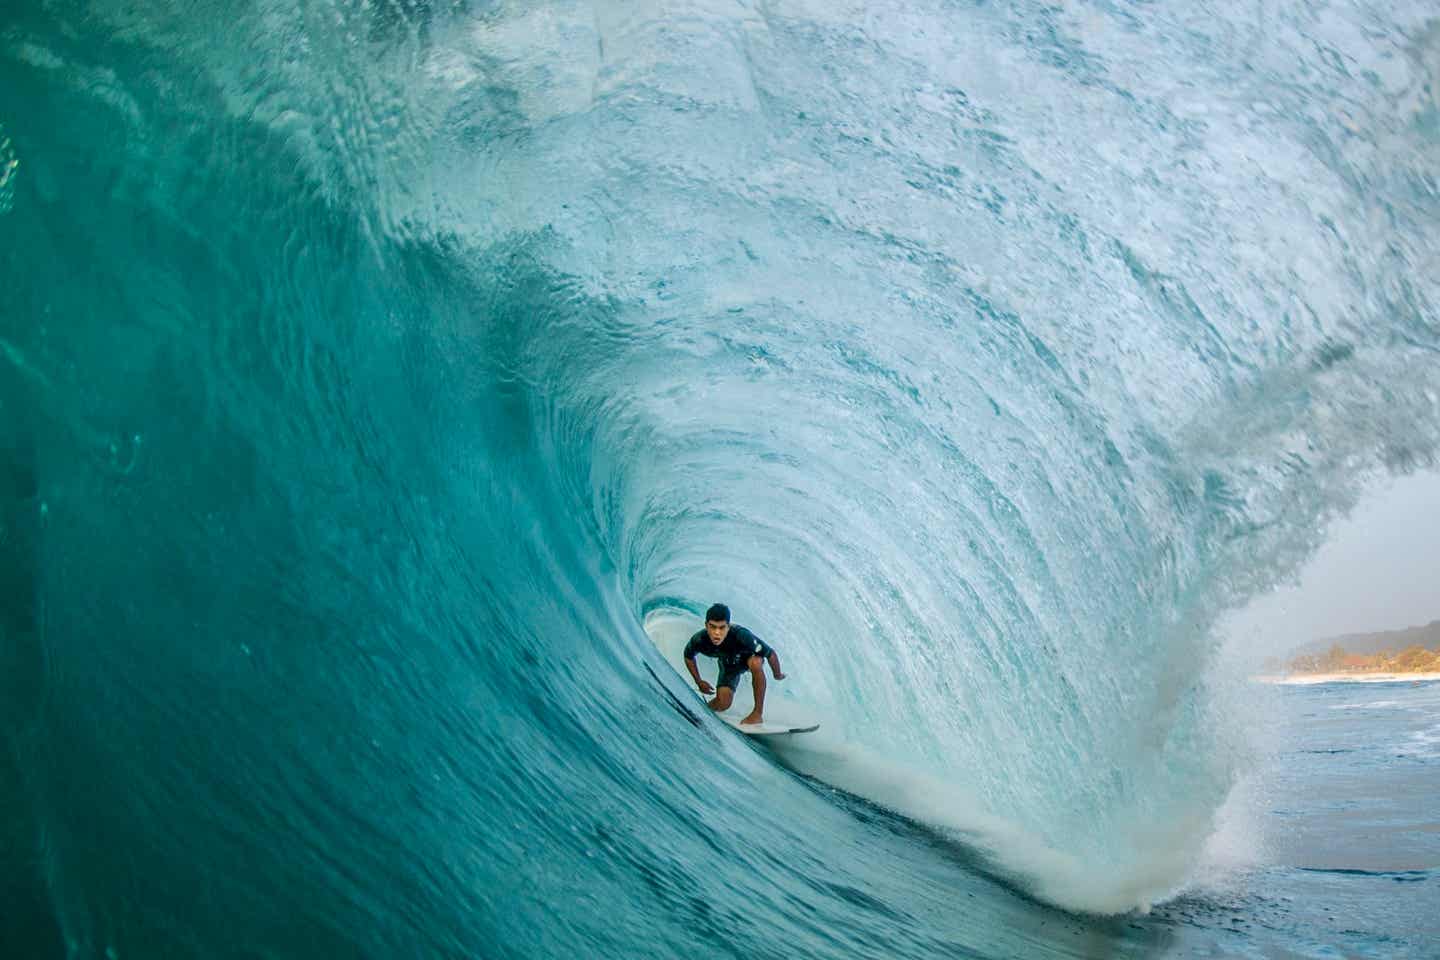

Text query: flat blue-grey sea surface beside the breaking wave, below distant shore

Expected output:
[1151,681,1440,957]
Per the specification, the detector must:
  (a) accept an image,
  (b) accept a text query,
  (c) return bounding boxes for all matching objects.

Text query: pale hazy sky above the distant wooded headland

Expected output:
[1225,474,1440,655]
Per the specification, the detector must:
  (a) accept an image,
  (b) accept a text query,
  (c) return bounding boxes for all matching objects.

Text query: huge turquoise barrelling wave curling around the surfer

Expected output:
[0,0,1440,957]
